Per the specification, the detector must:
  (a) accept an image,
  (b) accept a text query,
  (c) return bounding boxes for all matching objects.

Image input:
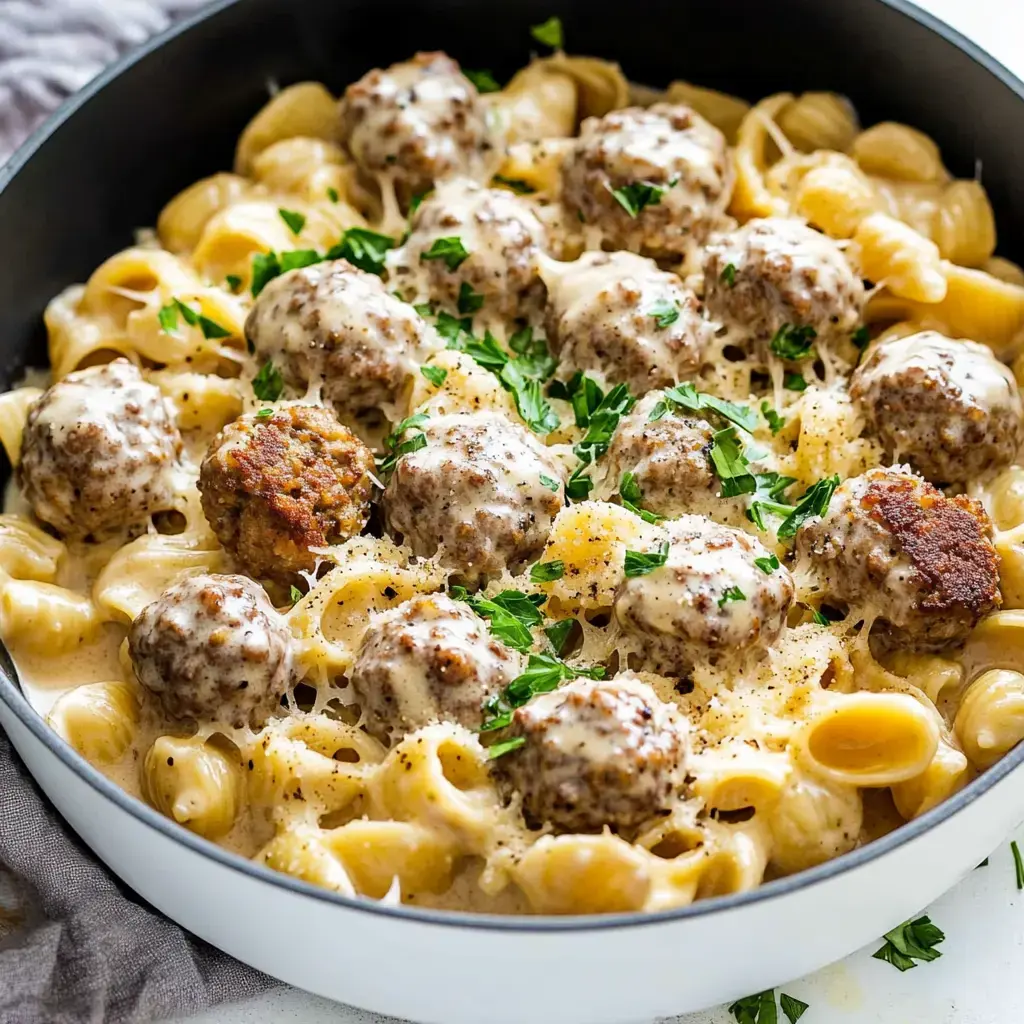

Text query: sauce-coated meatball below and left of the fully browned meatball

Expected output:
[128,575,299,729]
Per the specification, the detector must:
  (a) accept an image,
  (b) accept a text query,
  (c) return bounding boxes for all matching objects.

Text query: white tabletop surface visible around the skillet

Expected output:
[168,0,1024,1024]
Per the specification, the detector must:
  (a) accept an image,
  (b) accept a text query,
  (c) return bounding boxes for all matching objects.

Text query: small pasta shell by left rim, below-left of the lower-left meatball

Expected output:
[46,682,139,764]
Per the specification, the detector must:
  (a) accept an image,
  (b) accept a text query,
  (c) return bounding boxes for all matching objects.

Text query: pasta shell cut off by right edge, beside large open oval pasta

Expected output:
[954,663,1024,768]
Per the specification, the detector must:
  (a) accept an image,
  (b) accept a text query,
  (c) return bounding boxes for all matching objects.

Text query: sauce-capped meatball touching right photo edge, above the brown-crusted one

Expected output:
[850,331,1024,483]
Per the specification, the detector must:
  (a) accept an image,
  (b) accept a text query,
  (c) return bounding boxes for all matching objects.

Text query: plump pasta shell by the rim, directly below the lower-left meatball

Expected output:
[140,736,243,839]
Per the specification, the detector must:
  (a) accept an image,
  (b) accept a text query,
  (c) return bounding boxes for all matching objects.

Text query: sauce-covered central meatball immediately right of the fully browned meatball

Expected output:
[384,413,564,581]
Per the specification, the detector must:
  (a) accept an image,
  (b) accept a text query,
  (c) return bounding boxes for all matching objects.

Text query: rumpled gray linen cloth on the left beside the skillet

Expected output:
[0,0,274,1024]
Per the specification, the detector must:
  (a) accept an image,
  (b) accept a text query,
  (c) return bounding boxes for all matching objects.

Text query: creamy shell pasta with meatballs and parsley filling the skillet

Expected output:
[6,28,1024,913]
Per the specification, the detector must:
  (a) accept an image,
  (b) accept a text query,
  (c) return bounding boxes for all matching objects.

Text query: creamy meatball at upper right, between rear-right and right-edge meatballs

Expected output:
[703,217,864,361]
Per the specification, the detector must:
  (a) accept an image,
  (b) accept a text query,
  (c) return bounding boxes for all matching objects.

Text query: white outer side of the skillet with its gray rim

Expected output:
[0,677,1024,1024]
